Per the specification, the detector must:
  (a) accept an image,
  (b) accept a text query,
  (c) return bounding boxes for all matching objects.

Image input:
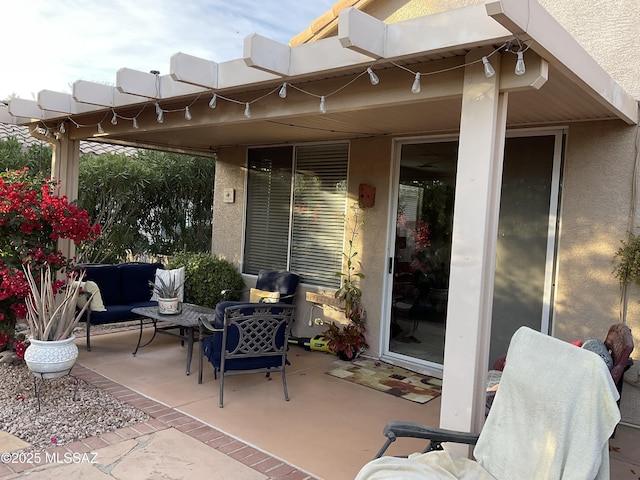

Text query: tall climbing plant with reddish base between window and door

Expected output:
[323,205,369,360]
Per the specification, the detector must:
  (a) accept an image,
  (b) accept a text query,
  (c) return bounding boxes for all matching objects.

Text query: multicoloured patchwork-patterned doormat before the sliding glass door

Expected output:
[326,359,442,403]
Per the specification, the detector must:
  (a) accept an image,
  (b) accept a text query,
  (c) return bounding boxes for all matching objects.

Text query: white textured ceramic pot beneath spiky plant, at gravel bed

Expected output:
[24,335,78,379]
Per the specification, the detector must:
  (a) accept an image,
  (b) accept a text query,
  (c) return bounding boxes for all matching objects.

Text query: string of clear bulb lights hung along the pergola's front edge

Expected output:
[32,37,529,134]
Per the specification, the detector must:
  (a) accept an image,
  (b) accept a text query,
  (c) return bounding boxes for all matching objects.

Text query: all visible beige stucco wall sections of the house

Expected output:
[213,0,640,424]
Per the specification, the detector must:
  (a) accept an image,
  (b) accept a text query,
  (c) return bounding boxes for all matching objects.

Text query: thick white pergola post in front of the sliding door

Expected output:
[440,50,507,442]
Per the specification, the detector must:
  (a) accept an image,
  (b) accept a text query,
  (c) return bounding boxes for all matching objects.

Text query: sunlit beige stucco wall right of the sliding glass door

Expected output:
[554,122,640,340]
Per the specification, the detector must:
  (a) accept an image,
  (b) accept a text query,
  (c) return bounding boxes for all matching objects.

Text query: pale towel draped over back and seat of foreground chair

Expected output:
[356,327,620,480]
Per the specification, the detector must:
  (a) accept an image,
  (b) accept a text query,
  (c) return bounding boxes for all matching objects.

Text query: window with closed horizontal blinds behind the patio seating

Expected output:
[244,144,349,288]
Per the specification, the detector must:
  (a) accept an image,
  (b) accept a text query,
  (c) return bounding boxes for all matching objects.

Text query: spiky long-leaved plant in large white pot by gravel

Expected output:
[23,265,89,379]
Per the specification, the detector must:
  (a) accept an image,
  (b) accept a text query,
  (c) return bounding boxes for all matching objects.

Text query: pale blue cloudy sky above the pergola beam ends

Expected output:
[0,0,336,100]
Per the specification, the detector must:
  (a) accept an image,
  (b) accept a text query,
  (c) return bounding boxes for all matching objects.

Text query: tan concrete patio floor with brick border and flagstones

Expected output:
[0,324,640,480]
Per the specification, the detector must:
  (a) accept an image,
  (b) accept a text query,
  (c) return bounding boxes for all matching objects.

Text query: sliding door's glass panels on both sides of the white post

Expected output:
[386,130,563,366]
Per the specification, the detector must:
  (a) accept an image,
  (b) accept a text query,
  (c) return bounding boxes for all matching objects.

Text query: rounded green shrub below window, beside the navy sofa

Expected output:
[167,252,245,308]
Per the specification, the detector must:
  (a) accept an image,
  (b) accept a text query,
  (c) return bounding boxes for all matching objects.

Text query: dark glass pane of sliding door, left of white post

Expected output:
[389,141,458,364]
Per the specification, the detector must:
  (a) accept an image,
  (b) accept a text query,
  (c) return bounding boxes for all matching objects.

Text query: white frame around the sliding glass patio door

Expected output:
[380,127,567,375]
